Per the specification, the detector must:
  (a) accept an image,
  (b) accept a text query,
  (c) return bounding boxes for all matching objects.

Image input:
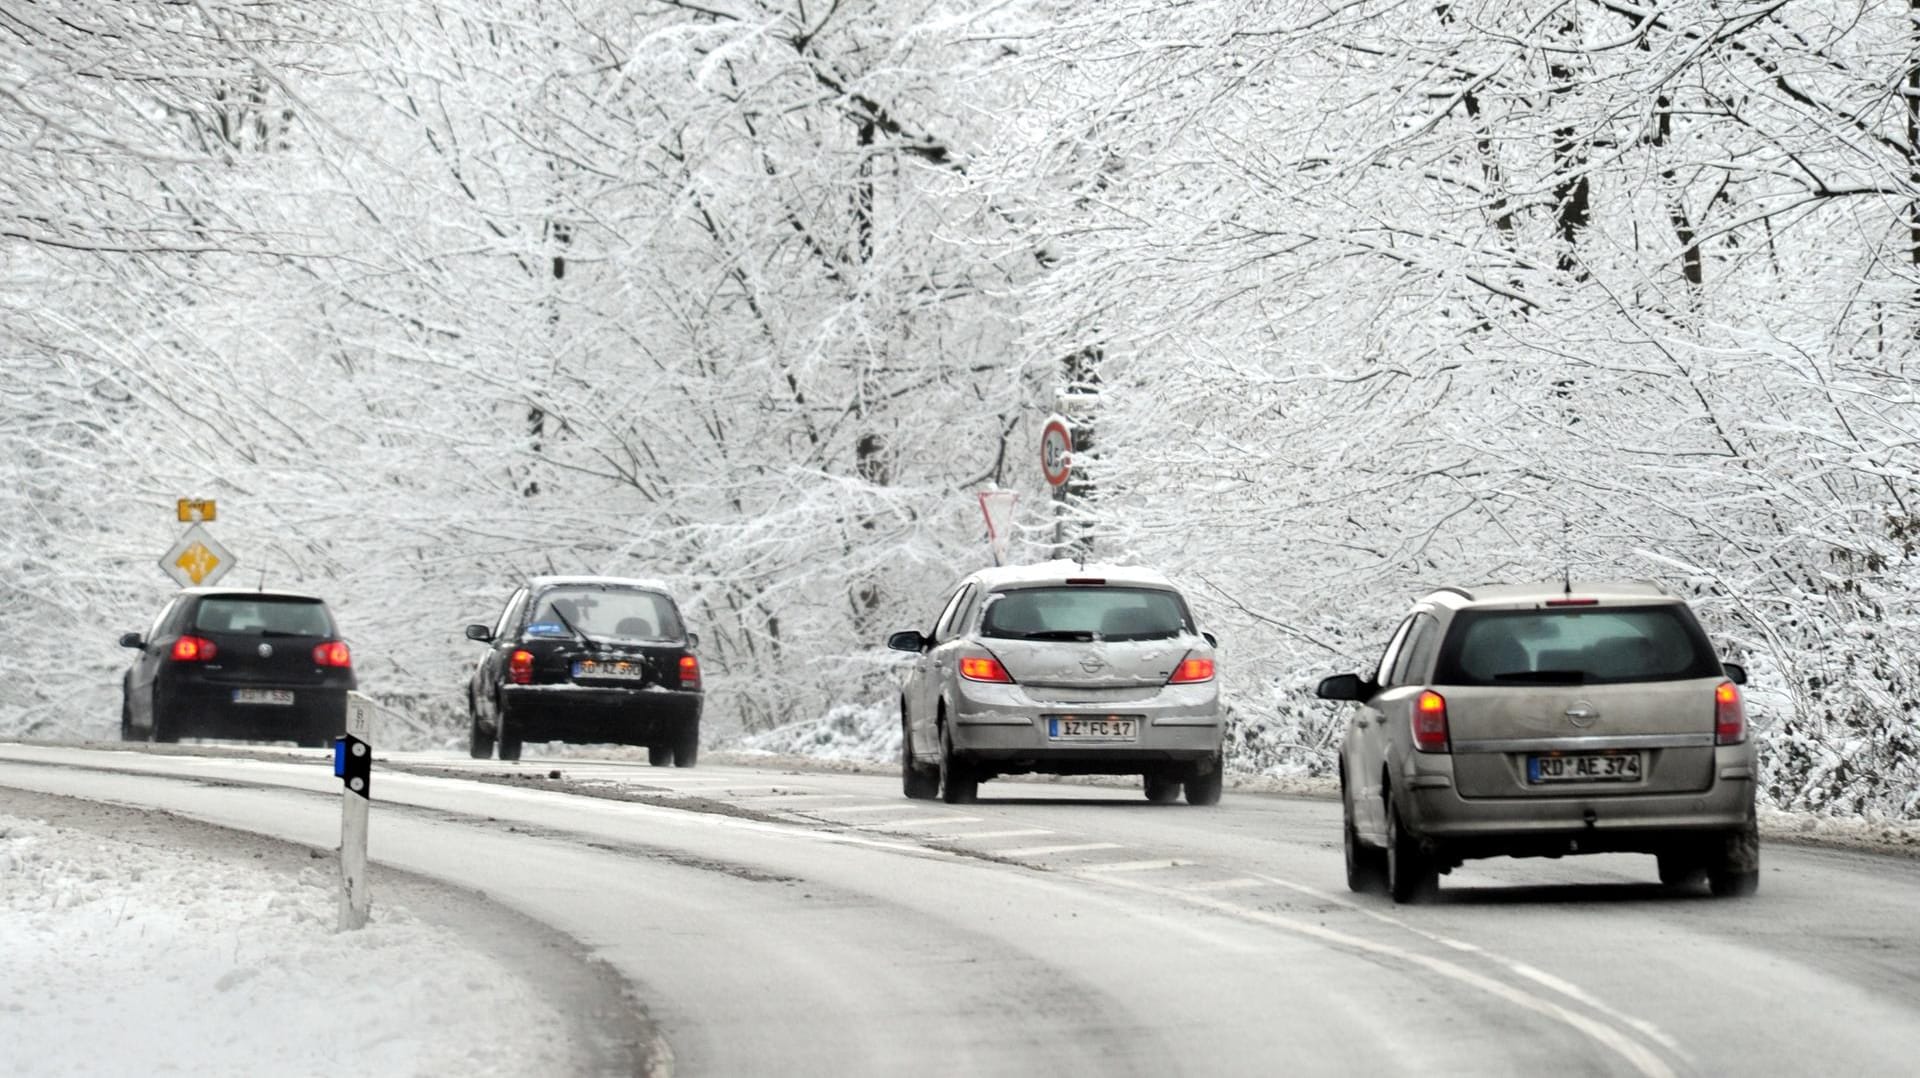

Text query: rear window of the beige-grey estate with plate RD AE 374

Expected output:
[1434,603,1722,684]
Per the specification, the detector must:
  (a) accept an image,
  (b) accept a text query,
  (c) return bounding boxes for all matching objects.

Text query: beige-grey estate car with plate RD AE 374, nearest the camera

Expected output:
[1319,582,1761,901]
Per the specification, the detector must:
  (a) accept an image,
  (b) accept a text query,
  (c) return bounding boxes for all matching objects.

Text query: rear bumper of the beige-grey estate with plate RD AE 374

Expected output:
[1398,742,1757,857]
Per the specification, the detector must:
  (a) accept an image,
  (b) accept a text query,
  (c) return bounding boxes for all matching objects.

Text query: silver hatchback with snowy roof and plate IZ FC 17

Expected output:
[887,561,1225,805]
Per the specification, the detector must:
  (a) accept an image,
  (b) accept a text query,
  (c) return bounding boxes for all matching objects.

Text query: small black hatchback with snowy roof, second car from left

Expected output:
[467,576,705,767]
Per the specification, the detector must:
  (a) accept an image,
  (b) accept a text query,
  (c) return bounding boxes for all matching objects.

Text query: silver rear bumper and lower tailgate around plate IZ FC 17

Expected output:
[948,682,1227,774]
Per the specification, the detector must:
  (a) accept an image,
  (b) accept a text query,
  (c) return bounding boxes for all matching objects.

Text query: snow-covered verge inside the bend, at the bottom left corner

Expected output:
[0,815,566,1078]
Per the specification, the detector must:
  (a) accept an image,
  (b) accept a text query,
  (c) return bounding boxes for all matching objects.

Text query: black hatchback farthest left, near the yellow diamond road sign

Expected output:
[119,588,357,747]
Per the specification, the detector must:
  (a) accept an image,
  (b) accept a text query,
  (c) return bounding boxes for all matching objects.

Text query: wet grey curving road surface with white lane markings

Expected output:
[0,744,1920,1078]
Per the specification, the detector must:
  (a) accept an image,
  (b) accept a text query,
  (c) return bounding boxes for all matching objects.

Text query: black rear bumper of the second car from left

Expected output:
[495,684,705,746]
